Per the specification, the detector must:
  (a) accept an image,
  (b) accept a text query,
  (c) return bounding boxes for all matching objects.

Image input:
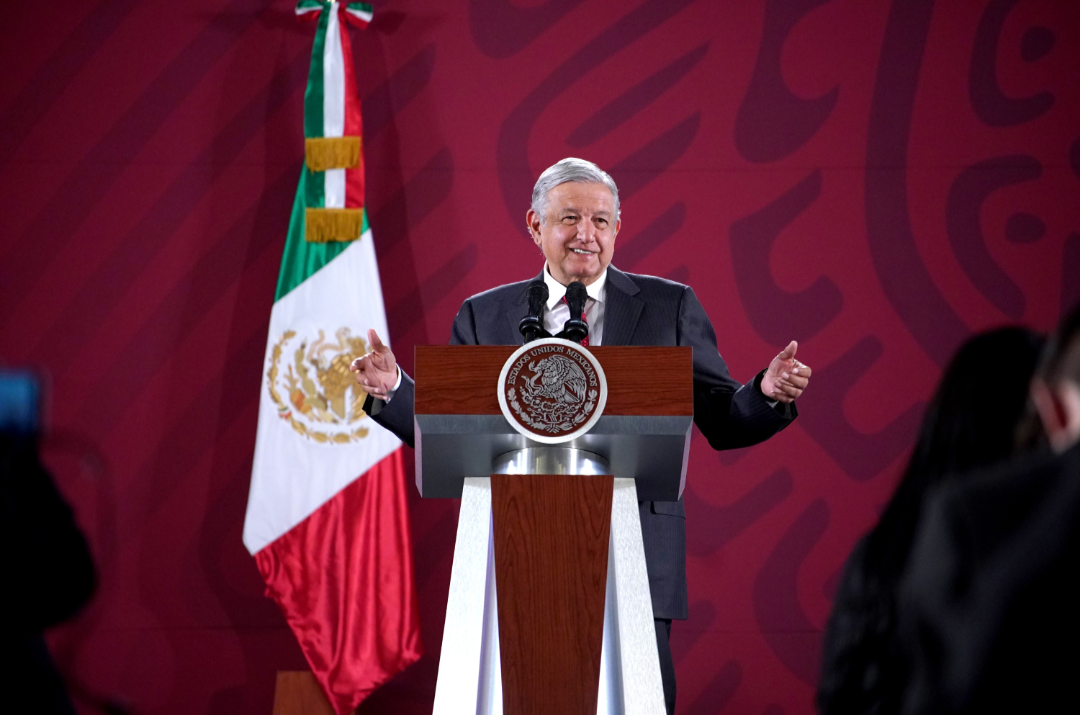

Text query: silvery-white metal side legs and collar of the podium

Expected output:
[434,447,665,715]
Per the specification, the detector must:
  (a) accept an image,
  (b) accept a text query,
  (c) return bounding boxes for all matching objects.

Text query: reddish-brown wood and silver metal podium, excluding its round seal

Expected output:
[415,346,693,715]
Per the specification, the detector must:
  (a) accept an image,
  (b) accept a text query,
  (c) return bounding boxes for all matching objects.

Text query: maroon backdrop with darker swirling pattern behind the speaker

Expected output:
[0,0,1080,715]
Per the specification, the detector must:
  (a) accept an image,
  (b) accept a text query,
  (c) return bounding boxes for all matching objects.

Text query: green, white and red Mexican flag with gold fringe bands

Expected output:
[244,0,422,715]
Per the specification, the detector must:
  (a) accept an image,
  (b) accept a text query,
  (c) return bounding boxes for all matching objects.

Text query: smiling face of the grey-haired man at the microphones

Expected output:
[525,181,621,285]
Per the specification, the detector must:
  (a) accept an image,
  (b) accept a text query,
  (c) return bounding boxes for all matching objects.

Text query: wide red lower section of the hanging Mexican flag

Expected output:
[255,449,422,715]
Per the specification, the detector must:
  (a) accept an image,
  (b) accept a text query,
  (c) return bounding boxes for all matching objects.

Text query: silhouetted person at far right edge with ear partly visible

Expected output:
[897,307,1080,715]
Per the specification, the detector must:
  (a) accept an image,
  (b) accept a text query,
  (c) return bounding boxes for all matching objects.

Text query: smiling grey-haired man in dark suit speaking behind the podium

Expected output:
[352,159,811,713]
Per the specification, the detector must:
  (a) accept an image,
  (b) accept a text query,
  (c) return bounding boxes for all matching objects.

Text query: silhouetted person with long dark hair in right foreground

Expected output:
[816,327,1042,714]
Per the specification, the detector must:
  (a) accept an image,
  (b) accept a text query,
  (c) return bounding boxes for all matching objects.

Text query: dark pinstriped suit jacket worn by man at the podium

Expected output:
[367,267,797,619]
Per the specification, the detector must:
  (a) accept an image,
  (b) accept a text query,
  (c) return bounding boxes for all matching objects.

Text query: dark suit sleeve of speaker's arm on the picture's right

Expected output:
[678,287,798,449]
